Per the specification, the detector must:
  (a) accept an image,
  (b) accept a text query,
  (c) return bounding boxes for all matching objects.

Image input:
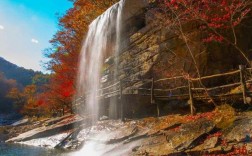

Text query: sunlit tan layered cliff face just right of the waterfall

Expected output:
[104,9,207,94]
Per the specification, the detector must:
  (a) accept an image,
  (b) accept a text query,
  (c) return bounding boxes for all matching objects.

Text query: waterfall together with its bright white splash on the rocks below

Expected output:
[76,0,147,156]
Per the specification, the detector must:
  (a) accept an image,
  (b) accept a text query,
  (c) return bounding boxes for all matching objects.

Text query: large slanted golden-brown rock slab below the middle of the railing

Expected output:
[134,119,215,155]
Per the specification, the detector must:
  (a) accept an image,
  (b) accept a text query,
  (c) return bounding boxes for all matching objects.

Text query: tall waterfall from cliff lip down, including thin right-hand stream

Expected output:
[77,0,148,123]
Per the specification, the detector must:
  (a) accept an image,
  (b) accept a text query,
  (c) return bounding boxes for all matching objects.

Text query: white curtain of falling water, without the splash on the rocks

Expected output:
[77,0,124,123]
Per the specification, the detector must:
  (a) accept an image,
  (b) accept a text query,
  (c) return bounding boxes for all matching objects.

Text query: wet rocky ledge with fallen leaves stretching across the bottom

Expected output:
[0,105,252,156]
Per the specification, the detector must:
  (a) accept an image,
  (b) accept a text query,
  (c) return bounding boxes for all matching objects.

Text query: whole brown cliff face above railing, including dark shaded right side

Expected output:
[103,2,252,90]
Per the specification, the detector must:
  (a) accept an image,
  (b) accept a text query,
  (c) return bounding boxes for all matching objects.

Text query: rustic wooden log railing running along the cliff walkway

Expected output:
[76,65,252,117]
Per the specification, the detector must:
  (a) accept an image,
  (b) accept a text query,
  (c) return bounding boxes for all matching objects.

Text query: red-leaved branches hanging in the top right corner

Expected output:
[160,0,251,42]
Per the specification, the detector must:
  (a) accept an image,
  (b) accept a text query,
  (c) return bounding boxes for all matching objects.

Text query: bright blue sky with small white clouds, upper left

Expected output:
[0,0,72,71]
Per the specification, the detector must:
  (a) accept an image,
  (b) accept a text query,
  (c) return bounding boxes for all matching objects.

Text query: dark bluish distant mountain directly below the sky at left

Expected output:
[0,57,42,86]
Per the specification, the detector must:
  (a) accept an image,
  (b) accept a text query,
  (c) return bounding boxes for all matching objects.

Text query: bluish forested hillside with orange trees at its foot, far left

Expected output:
[0,57,49,114]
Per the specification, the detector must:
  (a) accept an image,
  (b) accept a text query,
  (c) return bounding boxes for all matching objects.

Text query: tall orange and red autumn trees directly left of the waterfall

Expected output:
[46,0,117,113]
